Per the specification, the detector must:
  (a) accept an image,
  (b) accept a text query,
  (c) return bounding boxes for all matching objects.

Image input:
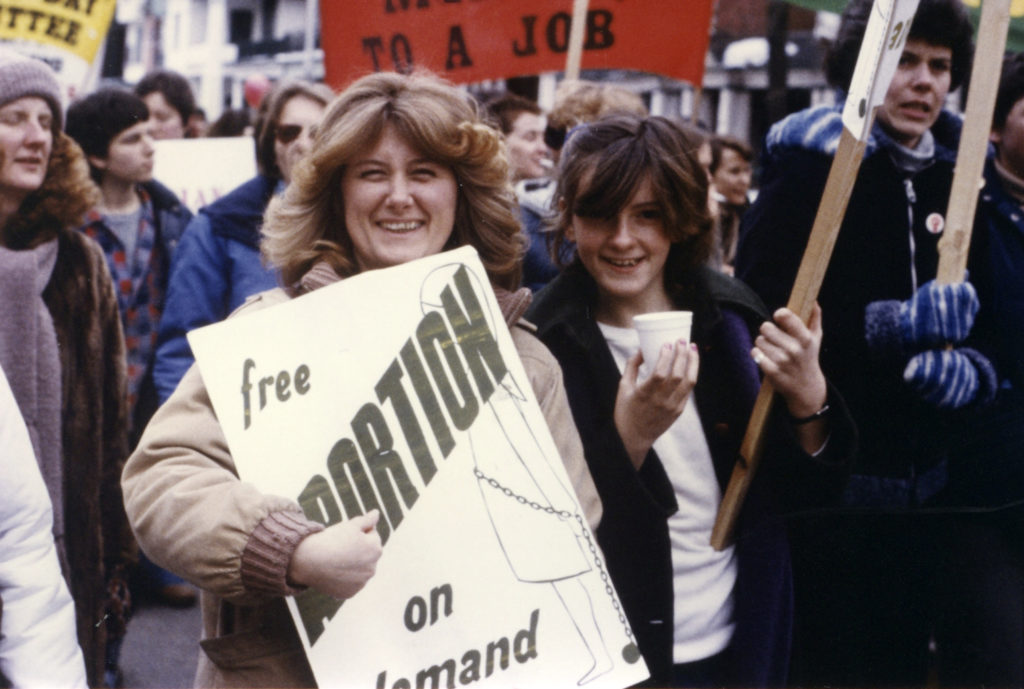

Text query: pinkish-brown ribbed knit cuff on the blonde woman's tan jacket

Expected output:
[242,511,324,596]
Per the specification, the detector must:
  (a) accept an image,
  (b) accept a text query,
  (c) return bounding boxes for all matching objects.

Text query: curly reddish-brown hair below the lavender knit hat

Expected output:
[0,132,99,250]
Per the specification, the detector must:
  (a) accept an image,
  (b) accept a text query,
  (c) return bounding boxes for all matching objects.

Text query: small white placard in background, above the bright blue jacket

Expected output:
[153,136,256,213]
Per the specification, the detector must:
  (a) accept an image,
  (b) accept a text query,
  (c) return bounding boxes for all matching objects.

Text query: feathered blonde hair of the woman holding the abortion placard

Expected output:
[262,67,525,290]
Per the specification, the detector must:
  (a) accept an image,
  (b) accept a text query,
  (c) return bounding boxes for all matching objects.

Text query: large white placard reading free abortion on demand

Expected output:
[188,248,647,689]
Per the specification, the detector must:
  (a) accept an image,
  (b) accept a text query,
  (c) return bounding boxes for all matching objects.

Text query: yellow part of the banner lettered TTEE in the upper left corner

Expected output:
[0,0,117,63]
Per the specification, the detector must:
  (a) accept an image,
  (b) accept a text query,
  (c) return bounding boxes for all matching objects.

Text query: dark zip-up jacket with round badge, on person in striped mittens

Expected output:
[736,106,988,507]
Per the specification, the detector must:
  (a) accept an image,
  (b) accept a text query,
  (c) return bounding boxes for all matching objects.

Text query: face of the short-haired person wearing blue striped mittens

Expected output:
[878,38,953,148]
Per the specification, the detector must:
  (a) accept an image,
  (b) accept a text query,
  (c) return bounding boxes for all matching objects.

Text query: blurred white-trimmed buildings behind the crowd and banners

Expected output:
[101,0,838,151]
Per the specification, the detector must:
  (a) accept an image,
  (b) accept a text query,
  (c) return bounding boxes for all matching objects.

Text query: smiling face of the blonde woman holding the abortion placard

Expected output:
[341,126,459,270]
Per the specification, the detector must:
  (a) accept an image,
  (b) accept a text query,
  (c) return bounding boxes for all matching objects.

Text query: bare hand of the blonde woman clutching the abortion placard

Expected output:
[288,510,383,599]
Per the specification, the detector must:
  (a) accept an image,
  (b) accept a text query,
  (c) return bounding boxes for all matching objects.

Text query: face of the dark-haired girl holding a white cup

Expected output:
[565,173,673,321]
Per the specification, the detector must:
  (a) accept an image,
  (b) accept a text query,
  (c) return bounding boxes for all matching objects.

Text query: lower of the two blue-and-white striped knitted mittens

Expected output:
[903,347,996,410]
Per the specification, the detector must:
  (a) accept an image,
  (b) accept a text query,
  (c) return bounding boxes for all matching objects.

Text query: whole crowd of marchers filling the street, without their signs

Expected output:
[0,0,1024,687]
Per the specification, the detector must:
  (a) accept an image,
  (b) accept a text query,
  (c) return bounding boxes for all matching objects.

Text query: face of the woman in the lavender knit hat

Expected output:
[0,96,53,203]
